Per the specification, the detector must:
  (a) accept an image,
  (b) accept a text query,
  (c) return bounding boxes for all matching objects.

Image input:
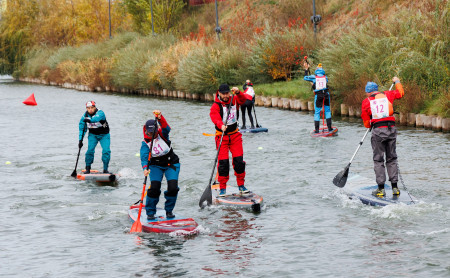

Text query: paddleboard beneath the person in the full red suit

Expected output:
[211,184,263,212]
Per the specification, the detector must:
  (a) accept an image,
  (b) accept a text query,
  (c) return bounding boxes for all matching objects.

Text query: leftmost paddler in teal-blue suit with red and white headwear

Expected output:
[78,100,111,174]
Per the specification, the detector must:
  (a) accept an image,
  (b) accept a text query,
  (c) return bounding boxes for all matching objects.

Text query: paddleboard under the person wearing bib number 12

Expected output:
[343,175,418,206]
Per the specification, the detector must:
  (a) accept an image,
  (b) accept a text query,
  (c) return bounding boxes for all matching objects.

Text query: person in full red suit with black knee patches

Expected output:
[209,84,249,196]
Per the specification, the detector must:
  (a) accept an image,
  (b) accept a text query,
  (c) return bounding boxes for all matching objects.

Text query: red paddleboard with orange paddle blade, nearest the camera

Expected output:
[128,205,198,233]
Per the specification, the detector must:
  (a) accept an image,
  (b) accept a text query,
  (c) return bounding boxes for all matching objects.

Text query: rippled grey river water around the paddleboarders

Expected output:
[0,78,450,277]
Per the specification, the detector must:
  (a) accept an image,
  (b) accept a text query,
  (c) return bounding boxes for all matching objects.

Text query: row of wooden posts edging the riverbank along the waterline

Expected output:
[18,77,450,132]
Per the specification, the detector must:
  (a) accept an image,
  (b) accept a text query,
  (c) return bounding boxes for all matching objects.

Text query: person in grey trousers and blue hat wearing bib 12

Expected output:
[361,77,405,197]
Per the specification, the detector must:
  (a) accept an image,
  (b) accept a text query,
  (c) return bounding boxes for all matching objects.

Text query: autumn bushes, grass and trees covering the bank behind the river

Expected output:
[0,0,450,121]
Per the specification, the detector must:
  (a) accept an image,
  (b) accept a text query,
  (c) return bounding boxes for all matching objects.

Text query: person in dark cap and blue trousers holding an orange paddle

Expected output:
[140,110,180,220]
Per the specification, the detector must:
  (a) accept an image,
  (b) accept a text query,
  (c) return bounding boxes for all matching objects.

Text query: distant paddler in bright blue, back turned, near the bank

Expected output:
[303,64,333,133]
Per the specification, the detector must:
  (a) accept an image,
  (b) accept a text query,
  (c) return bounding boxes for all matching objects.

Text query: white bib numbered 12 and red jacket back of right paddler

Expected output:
[368,92,395,125]
